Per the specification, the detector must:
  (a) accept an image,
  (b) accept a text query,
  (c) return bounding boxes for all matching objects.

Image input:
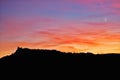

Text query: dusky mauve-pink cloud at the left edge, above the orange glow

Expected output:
[0,17,54,39]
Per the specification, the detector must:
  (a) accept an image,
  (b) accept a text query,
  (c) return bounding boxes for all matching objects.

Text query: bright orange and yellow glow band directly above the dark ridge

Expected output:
[0,26,120,57]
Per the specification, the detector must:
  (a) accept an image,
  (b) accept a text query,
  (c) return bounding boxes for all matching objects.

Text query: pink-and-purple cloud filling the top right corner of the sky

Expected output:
[62,0,120,16]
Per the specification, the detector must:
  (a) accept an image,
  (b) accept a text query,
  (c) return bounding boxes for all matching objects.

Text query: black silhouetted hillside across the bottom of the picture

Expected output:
[0,48,120,79]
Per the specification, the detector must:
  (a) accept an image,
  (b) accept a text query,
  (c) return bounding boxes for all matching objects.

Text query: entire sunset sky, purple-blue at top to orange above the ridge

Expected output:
[0,0,120,57]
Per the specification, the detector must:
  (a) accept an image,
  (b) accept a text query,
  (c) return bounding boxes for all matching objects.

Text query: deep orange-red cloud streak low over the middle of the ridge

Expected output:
[31,28,100,45]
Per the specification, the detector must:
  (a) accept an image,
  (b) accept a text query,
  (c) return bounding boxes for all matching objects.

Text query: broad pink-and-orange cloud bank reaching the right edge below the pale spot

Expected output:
[30,19,119,46]
